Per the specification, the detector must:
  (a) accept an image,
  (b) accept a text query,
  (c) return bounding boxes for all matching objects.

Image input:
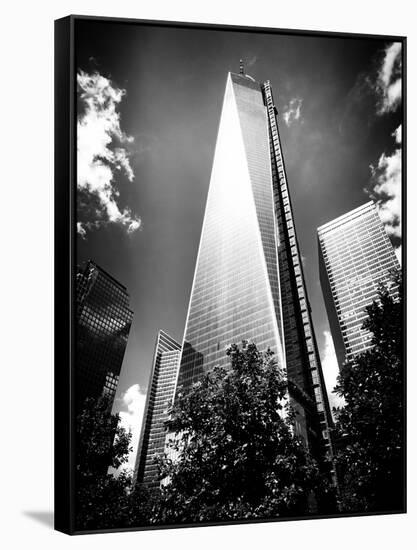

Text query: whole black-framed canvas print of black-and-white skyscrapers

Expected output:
[55,16,406,534]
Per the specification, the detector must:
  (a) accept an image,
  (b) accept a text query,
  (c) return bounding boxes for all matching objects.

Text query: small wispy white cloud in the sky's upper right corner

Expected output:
[376,42,402,114]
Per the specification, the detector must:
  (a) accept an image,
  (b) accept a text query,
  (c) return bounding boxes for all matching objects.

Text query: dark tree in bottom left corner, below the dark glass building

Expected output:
[75,396,150,530]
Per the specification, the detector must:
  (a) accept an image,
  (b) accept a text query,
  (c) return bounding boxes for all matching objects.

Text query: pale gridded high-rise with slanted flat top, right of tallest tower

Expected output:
[317,201,400,368]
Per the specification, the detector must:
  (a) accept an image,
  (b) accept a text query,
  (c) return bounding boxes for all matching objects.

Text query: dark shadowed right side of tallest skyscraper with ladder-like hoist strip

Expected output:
[263,81,333,458]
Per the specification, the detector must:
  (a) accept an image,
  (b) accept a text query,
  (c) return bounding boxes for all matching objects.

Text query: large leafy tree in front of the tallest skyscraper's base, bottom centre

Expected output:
[153,341,323,523]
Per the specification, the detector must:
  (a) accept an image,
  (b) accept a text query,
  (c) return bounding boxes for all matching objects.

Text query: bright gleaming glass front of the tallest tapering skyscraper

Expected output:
[174,73,285,388]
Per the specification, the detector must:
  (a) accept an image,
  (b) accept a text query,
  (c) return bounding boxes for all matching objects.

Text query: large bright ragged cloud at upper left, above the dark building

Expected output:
[77,70,141,237]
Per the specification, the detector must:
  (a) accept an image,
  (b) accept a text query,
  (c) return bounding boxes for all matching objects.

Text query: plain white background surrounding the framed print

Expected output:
[0,0,417,550]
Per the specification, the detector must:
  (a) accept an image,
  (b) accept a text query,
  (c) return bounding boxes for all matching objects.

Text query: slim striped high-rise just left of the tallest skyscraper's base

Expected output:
[134,330,181,488]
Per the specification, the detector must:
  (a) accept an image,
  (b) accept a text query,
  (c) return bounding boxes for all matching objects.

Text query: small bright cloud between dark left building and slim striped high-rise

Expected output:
[114,384,146,478]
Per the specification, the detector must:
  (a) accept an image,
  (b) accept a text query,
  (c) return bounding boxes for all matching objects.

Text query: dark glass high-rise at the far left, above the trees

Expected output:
[75,260,133,410]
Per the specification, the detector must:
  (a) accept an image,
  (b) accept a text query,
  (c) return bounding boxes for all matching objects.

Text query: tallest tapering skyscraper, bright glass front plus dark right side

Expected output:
[177,72,331,466]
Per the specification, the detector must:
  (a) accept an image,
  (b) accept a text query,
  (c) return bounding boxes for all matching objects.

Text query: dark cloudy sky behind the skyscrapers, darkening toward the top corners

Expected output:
[75,21,402,472]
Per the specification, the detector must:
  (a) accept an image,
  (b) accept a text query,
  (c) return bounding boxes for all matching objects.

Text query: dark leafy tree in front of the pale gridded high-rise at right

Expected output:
[335,276,404,512]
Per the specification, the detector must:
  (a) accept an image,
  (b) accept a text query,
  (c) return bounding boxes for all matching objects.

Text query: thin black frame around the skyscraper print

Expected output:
[54,15,407,535]
